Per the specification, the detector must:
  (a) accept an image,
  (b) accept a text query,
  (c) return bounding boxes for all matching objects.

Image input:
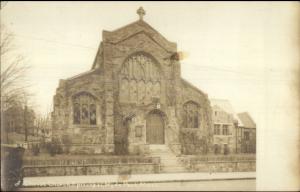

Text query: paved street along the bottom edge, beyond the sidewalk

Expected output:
[19,179,256,191]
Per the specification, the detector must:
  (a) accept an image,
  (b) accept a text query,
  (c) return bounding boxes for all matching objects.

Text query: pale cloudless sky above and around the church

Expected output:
[1,2,299,189]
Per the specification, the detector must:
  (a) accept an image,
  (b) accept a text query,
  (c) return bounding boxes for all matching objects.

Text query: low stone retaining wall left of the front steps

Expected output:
[23,157,159,177]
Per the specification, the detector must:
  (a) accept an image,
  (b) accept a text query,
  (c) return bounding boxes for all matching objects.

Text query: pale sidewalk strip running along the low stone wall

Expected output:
[23,172,256,187]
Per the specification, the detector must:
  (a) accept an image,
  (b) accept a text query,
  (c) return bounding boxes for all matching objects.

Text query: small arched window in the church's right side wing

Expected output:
[182,101,200,128]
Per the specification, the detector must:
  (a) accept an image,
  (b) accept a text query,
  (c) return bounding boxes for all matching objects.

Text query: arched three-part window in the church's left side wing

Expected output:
[73,92,97,125]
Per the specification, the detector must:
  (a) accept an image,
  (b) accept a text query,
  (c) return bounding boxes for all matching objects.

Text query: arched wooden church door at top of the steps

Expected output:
[146,111,165,144]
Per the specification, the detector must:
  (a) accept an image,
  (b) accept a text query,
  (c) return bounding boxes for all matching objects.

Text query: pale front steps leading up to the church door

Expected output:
[150,145,186,173]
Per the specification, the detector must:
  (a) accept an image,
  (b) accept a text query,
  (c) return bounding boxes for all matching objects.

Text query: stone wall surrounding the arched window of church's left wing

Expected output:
[52,70,103,132]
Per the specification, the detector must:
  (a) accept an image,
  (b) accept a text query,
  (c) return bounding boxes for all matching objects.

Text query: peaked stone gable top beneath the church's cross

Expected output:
[102,20,177,52]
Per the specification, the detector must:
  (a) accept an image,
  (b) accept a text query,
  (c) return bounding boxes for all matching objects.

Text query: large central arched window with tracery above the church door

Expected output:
[119,53,161,104]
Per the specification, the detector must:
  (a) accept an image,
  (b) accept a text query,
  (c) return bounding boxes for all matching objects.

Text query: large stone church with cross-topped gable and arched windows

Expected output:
[52,8,212,154]
